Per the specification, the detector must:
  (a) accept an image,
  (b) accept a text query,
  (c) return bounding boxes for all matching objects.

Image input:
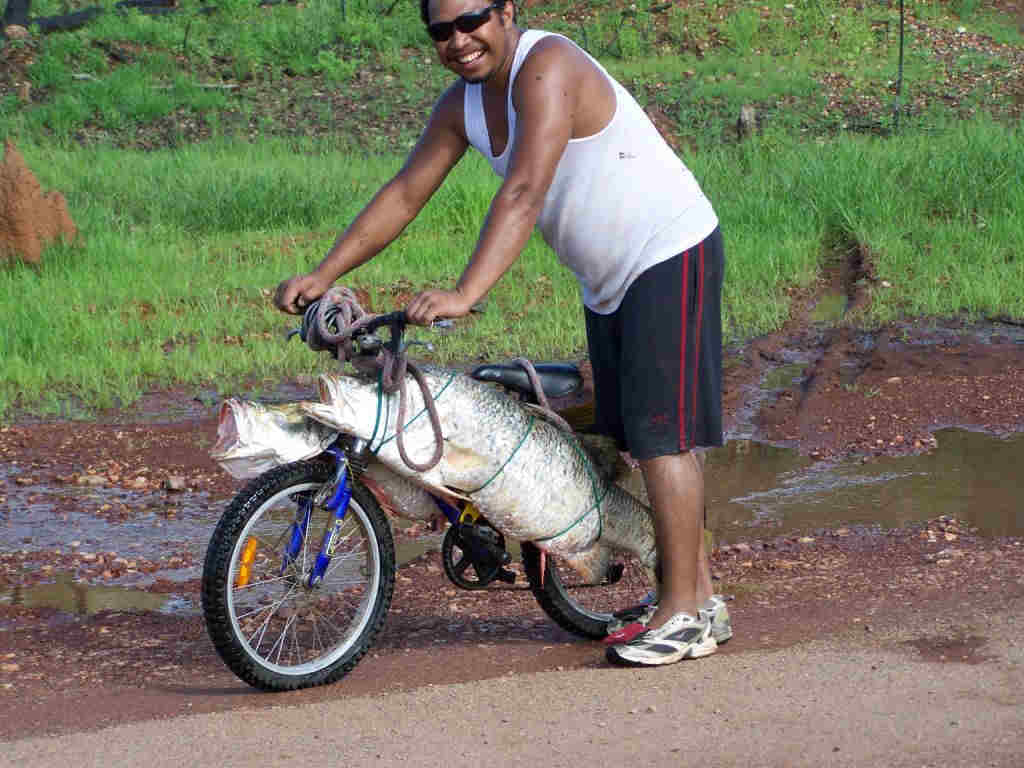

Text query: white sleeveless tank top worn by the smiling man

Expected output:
[463,30,718,314]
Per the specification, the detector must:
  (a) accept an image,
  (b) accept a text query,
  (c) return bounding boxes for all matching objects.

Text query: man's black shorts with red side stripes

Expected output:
[586,227,725,460]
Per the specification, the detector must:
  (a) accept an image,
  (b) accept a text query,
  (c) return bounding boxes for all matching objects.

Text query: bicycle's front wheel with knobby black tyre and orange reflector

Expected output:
[203,461,395,690]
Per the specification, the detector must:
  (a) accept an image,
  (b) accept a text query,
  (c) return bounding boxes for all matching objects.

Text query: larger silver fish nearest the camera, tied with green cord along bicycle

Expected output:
[301,367,656,583]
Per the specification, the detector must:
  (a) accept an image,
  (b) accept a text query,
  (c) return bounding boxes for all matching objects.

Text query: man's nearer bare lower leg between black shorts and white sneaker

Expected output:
[640,452,712,629]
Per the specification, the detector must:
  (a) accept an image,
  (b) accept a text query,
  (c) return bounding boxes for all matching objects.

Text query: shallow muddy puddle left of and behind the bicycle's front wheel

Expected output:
[0,465,442,615]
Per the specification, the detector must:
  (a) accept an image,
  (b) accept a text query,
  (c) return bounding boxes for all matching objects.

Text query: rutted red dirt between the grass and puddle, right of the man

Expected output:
[749,330,1024,458]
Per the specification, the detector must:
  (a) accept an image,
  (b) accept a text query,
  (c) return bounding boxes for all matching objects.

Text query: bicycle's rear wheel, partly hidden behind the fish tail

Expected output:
[522,542,655,640]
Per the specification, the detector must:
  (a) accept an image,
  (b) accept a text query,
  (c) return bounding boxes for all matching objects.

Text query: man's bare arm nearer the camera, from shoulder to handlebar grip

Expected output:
[407,41,577,325]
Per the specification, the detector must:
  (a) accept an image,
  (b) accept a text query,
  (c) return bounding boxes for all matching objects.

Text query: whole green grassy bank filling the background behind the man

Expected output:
[0,2,1024,415]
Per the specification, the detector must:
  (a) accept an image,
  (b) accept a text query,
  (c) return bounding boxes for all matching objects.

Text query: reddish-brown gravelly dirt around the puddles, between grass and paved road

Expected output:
[0,313,1024,739]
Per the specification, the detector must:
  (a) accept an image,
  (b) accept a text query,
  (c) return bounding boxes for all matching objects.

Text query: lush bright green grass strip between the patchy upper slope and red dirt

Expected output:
[0,114,1024,421]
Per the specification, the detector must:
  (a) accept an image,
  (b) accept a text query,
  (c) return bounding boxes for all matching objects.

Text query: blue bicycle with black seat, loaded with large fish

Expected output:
[202,312,651,691]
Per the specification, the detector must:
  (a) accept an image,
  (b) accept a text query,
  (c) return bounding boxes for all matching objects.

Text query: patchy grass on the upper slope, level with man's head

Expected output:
[6,0,1024,152]
